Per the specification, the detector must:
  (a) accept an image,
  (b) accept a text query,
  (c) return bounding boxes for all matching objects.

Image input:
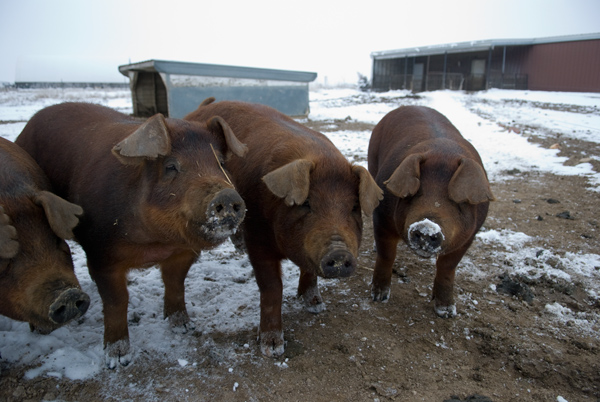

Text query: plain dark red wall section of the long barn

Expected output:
[524,40,600,92]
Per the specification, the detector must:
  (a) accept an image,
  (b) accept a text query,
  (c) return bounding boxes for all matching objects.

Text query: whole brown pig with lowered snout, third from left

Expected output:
[184,98,383,356]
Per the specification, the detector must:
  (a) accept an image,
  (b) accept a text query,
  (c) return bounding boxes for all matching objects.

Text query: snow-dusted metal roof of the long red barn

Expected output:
[371,33,600,60]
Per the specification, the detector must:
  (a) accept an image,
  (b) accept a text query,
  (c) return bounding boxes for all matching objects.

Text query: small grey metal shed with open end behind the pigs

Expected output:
[114,60,317,118]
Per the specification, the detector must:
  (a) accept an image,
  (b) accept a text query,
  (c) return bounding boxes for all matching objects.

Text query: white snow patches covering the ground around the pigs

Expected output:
[0,89,600,382]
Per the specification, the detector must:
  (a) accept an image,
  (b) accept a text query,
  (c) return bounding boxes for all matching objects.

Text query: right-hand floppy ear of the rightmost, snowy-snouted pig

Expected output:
[448,158,495,204]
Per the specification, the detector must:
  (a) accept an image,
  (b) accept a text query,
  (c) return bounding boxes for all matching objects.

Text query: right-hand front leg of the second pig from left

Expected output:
[160,253,197,334]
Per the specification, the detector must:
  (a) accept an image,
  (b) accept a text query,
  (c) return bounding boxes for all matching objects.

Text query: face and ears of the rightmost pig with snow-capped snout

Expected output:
[385,153,494,258]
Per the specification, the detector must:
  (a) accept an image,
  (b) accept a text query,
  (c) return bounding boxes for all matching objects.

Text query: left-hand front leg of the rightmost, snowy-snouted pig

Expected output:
[371,225,400,302]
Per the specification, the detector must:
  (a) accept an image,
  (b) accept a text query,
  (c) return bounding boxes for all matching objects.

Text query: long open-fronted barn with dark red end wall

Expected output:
[371,33,600,92]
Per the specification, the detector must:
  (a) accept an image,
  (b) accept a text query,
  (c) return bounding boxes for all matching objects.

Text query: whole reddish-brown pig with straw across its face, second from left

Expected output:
[16,103,247,369]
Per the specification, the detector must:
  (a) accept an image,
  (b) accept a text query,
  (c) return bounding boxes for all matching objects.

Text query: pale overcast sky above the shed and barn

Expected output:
[0,0,600,83]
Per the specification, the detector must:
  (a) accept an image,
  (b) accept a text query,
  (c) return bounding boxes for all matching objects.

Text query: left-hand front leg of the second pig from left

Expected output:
[88,262,132,369]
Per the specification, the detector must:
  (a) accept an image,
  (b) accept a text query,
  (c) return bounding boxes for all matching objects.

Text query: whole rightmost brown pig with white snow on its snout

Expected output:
[368,106,494,318]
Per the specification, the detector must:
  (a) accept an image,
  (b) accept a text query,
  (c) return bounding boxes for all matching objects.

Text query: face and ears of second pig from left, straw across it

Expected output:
[113,115,246,249]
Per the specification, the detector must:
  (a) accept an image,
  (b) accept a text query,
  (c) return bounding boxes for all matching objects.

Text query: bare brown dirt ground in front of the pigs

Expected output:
[0,95,600,402]
